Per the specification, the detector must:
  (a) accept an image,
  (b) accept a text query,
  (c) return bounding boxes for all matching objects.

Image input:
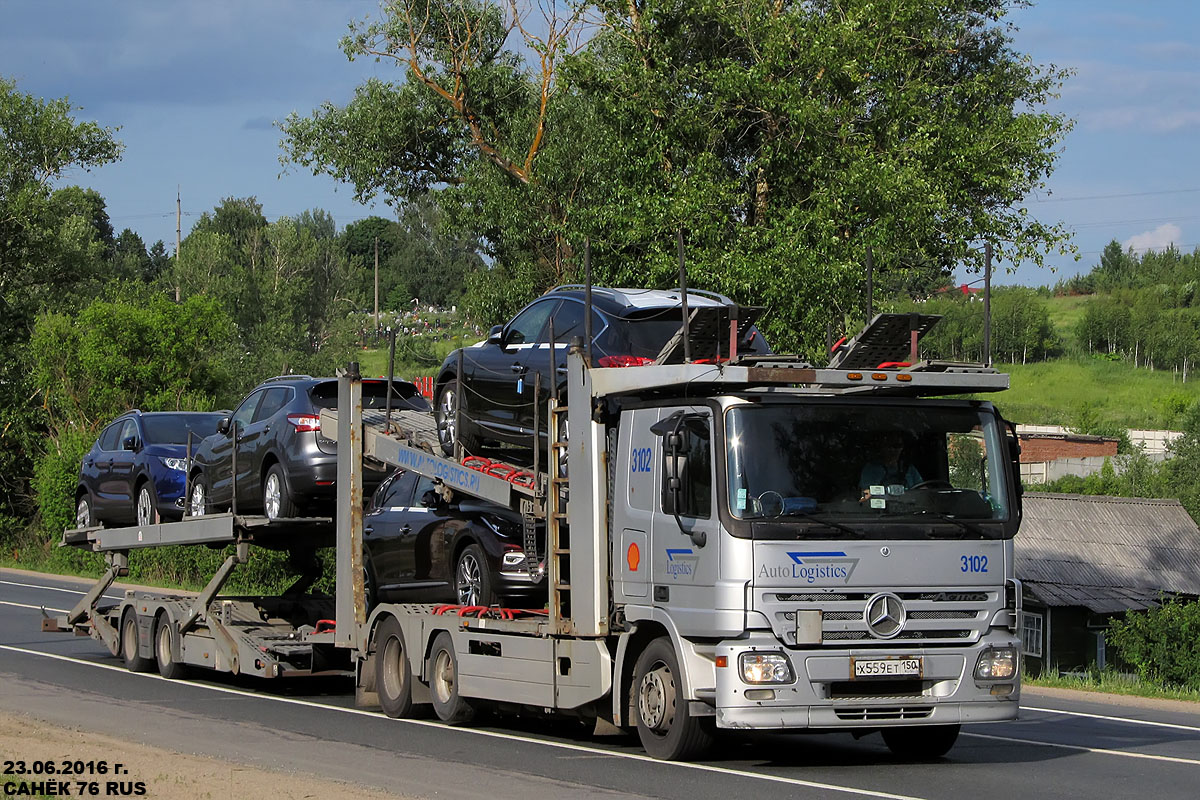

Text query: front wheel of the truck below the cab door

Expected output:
[634,636,714,762]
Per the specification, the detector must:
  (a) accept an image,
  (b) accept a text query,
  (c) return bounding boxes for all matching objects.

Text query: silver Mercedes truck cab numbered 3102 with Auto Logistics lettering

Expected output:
[610,387,1020,754]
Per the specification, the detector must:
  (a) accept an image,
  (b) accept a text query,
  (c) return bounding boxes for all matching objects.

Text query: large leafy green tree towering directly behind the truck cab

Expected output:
[283,0,1069,351]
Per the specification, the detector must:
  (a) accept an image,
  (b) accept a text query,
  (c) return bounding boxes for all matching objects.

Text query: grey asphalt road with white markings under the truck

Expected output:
[0,570,1200,800]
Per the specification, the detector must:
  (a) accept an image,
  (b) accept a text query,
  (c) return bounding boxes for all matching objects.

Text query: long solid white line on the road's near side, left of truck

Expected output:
[0,644,922,800]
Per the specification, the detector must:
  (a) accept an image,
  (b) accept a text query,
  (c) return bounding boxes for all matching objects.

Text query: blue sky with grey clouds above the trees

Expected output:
[0,0,1200,285]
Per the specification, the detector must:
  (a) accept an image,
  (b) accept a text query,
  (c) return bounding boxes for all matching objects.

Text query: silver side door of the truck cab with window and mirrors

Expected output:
[650,408,720,634]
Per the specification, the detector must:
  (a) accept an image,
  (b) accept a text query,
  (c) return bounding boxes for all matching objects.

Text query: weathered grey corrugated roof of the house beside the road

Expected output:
[1014,492,1200,613]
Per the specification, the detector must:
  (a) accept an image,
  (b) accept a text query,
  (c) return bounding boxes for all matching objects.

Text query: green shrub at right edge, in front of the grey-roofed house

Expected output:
[1109,599,1200,688]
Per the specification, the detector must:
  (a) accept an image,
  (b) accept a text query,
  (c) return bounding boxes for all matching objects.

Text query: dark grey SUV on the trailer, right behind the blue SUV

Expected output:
[187,375,430,519]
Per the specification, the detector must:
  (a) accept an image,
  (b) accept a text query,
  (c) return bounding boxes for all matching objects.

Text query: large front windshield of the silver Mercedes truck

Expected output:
[725,403,1009,536]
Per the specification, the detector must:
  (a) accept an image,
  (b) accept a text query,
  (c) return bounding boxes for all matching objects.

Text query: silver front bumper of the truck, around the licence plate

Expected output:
[715,632,1020,729]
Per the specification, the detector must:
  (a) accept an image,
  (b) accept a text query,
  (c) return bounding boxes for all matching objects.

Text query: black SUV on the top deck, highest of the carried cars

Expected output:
[433,285,770,455]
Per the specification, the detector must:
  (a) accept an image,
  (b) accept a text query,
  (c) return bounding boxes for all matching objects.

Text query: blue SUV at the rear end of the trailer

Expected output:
[76,409,223,528]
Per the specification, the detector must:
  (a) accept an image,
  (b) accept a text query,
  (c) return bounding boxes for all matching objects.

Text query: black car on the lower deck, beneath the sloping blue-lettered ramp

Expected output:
[362,470,547,608]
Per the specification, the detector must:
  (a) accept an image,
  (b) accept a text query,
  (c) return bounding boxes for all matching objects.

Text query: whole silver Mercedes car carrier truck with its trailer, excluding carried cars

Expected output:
[43,314,1021,759]
